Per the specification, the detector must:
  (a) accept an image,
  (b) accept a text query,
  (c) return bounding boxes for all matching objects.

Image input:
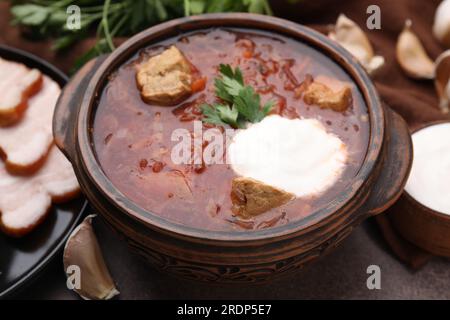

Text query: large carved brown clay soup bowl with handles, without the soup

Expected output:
[54,13,412,283]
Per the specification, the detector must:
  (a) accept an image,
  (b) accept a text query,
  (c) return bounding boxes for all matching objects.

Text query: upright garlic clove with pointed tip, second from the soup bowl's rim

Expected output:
[396,20,434,79]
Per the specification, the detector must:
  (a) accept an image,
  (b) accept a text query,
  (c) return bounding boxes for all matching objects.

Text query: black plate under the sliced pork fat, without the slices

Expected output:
[0,45,86,298]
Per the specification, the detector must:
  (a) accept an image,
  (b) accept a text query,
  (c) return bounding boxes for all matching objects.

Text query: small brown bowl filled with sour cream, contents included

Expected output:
[391,122,450,257]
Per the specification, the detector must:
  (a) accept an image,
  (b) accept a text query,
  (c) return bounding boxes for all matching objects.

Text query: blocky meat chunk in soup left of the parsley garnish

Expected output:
[136,46,192,105]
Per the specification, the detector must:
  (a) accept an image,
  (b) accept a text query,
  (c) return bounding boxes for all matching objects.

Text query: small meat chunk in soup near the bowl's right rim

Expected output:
[303,80,352,112]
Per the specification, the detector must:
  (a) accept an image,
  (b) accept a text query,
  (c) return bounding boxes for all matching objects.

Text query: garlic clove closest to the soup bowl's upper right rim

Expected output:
[328,14,384,74]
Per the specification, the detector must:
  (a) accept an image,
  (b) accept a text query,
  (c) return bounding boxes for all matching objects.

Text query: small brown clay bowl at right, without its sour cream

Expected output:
[389,121,450,257]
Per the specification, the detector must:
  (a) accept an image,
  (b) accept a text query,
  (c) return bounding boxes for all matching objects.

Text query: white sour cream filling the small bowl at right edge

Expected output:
[405,123,450,215]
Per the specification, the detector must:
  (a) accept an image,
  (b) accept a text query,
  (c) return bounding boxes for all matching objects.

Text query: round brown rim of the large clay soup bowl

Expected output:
[75,13,385,242]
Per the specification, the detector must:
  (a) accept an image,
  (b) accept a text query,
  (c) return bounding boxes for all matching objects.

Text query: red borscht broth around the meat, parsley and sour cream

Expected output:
[93,29,370,231]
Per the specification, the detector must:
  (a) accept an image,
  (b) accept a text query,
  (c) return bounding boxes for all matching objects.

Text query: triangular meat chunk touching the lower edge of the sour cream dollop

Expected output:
[231,177,295,218]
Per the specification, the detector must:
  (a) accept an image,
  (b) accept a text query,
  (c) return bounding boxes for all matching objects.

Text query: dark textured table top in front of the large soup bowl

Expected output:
[15,220,450,299]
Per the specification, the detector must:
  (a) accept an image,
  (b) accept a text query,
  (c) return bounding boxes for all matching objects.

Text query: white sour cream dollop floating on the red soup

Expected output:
[228,115,348,197]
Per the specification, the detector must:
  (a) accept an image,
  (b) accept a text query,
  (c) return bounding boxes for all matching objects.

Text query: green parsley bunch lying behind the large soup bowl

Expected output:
[11,0,272,68]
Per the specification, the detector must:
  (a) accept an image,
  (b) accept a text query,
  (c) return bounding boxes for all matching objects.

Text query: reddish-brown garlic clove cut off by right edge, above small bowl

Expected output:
[434,50,450,113]
